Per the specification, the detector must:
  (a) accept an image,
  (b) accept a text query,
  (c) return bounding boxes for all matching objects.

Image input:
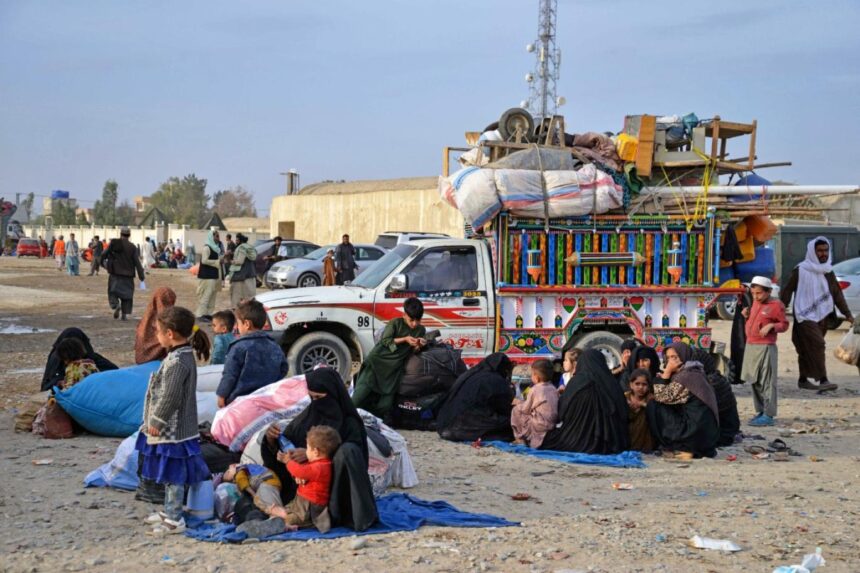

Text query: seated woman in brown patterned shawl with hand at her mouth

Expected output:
[646,342,720,458]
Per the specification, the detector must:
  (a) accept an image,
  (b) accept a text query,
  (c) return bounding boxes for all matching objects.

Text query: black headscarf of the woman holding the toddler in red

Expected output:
[284,367,368,460]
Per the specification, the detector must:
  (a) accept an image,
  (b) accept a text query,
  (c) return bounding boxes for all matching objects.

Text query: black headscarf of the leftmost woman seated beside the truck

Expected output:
[436,352,514,429]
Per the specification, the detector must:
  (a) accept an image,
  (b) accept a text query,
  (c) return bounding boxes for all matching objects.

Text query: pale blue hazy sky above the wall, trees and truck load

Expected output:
[0,0,860,214]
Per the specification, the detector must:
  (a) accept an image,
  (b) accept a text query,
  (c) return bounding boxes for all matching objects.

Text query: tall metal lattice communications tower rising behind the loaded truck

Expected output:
[523,0,564,119]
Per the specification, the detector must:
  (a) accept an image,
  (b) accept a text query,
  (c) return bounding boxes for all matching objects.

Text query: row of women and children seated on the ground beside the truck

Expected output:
[437,342,740,459]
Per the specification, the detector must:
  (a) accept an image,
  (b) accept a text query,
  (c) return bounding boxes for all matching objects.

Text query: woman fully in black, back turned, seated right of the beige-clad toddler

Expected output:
[541,349,630,454]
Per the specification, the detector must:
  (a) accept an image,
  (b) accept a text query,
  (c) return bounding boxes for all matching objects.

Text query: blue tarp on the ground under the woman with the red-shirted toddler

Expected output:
[185,493,519,543]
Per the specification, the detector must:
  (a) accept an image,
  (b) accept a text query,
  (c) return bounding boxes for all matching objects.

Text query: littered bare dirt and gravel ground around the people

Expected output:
[0,257,860,573]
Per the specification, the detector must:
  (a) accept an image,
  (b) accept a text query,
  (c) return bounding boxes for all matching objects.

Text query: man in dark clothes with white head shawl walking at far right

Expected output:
[780,237,854,392]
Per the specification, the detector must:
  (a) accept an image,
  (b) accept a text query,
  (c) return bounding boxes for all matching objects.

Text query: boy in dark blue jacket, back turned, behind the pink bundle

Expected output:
[215,299,289,408]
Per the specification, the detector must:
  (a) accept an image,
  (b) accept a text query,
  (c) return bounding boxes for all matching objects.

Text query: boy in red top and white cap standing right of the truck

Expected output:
[741,277,788,426]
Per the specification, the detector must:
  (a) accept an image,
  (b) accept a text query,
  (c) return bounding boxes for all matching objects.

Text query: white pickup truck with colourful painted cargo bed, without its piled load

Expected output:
[257,214,739,379]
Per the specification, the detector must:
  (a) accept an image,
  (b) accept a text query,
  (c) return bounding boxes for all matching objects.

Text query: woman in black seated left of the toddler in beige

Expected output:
[436,352,514,442]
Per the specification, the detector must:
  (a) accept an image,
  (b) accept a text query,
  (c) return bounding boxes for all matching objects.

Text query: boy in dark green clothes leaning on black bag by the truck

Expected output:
[352,297,427,418]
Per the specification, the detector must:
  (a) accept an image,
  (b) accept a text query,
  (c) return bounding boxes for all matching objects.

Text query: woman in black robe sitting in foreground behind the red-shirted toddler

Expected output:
[261,368,378,531]
